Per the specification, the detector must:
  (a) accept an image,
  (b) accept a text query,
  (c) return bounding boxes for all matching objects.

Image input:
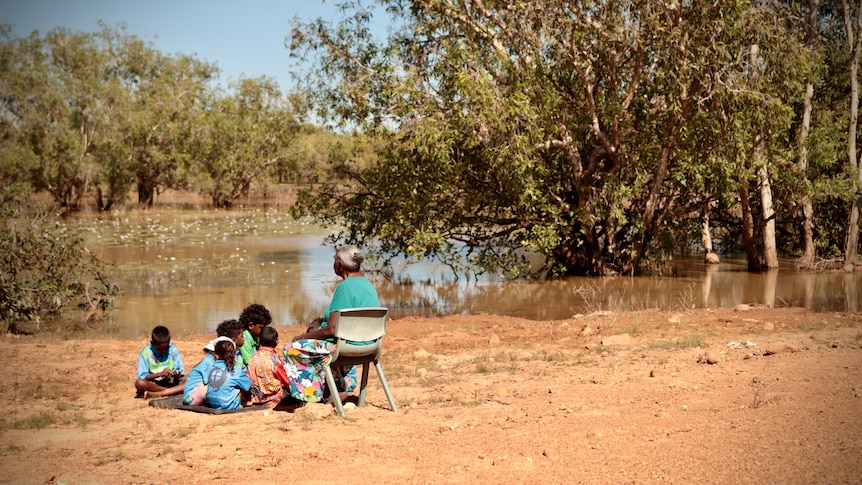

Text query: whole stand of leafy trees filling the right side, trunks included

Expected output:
[289,0,862,275]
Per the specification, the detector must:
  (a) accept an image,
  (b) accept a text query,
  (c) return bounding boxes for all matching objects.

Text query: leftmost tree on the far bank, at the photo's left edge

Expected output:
[0,28,110,209]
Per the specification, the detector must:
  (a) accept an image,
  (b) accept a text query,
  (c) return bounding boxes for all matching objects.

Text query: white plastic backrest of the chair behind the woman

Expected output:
[335,307,389,358]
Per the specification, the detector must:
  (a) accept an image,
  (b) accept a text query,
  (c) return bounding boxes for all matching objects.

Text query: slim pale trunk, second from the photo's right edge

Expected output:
[796,0,820,269]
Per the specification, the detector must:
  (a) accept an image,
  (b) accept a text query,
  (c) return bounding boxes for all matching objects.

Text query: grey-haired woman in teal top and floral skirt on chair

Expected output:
[283,245,380,402]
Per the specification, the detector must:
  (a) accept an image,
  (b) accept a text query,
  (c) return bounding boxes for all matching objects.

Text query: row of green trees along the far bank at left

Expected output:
[0,24,352,210]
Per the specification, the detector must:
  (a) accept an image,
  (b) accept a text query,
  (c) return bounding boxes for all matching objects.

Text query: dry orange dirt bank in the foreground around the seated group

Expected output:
[0,307,862,484]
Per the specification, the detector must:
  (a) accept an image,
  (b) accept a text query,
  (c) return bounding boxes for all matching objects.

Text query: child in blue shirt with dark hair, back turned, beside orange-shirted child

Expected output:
[206,339,252,409]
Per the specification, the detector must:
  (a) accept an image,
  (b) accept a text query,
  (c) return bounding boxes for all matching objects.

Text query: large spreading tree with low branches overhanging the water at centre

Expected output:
[290,0,784,275]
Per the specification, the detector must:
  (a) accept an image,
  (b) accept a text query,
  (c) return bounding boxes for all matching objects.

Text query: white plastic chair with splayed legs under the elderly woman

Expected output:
[324,308,398,417]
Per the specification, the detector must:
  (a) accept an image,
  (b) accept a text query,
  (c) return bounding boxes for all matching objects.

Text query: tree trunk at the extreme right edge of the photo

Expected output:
[841,0,862,271]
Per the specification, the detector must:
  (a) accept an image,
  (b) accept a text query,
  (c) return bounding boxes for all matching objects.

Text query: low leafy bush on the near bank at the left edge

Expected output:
[0,201,119,332]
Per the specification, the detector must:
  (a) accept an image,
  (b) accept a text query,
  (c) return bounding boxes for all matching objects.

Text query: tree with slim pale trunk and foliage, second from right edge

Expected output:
[778,0,856,268]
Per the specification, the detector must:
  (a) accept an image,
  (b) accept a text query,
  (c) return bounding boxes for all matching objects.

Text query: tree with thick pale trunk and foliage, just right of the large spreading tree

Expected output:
[705,1,808,270]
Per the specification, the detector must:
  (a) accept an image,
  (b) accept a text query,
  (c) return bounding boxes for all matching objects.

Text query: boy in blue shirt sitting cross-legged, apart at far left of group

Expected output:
[135,325,186,398]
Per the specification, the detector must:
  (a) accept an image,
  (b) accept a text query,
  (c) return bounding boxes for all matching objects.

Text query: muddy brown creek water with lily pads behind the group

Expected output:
[62,208,862,338]
